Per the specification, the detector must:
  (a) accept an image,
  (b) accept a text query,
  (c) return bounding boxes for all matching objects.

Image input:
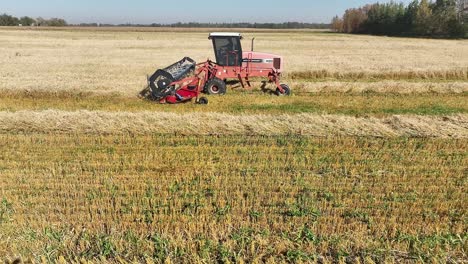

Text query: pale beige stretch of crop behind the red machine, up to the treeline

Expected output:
[0,29,468,96]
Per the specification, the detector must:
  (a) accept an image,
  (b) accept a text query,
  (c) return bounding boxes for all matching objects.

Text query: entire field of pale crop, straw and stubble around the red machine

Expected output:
[0,28,468,263]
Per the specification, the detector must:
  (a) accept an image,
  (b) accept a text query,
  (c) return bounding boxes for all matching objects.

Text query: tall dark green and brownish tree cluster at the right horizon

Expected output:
[331,0,468,38]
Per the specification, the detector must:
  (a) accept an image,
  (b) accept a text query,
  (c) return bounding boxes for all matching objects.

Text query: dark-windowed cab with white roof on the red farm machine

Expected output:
[209,32,242,66]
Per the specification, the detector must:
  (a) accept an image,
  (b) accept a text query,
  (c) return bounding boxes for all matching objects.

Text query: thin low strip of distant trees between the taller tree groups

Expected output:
[75,22,331,29]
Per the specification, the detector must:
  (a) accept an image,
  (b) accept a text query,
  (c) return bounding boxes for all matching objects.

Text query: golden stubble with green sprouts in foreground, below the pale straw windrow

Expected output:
[0,133,468,263]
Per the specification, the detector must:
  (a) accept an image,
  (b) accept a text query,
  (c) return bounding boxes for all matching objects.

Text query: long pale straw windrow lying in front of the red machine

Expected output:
[0,110,468,139]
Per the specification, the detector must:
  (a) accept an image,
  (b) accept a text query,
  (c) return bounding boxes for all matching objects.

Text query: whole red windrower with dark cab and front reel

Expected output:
[146,33,291,104]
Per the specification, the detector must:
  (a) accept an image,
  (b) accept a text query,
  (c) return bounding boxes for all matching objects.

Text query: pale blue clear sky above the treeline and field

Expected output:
[0,0,410,24]
